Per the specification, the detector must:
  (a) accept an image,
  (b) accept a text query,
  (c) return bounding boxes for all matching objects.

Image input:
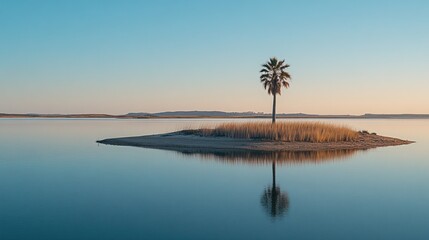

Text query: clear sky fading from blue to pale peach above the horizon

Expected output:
[0,0,429,114]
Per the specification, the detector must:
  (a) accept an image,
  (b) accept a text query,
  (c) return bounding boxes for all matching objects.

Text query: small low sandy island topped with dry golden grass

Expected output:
[97,122,413,152]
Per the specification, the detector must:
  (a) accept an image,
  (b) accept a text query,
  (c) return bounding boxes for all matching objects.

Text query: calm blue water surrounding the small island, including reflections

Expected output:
[0,119,429,239]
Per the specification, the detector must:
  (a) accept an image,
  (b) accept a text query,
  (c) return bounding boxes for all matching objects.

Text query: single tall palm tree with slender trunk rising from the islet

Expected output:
[260,57,291,123]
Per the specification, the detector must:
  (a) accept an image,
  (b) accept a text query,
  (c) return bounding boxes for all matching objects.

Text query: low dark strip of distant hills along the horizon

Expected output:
[0,111,429,119]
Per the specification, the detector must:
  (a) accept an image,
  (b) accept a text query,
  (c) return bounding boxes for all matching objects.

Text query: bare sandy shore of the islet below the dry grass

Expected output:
[97,131,413,152]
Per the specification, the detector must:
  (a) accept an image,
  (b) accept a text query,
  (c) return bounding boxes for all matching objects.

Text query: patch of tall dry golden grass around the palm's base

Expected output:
[200,122,359,143]
